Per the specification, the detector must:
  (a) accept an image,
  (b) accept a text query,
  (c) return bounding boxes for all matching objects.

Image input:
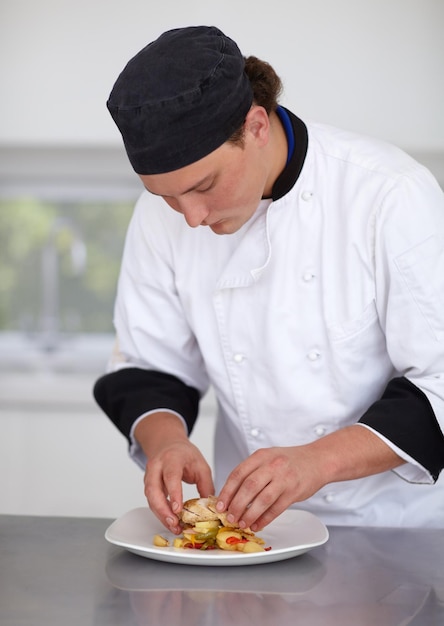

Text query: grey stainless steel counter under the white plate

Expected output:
[0,516,444,626]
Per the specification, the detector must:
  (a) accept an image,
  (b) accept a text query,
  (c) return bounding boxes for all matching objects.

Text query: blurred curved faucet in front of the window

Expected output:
[39,217,87,352]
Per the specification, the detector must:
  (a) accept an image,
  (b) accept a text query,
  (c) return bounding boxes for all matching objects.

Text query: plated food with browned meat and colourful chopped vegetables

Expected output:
[153,496,271,554]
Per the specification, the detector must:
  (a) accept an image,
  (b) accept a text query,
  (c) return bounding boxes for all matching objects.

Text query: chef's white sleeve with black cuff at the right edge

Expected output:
[366,166,444,482]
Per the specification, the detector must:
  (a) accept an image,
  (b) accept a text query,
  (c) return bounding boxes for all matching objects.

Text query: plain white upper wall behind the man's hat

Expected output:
[0,0,444,152]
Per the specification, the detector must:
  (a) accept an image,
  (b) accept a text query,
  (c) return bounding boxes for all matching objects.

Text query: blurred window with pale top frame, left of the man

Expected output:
[0,148,141,358]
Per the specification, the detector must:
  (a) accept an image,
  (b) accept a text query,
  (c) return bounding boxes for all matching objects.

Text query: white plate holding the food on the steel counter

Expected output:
[105,507,328,565]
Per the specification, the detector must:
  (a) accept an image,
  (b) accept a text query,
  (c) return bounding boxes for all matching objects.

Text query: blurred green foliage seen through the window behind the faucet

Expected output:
[0,198,133,333]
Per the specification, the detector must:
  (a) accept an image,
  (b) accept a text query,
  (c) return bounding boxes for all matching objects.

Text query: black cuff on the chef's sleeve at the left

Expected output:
[93,367,199,441]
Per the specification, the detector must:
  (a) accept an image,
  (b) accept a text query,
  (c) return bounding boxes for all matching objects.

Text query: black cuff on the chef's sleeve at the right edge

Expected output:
[359,378,444,481]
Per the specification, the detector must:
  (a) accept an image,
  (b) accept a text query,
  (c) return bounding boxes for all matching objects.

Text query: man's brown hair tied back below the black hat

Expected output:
[228,56,282,147]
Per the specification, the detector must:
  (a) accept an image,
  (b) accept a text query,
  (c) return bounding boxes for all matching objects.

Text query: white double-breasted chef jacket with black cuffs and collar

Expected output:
[95,112,444,526]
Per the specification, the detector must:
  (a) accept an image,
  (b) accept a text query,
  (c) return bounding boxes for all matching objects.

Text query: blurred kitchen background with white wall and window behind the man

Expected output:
[0,0,444,517]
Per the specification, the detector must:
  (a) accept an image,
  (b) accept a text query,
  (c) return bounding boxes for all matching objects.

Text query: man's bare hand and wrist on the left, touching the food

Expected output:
[134,412,214,534]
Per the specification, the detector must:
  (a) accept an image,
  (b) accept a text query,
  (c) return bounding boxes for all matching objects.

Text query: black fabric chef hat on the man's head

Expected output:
[107,26,253,174]
